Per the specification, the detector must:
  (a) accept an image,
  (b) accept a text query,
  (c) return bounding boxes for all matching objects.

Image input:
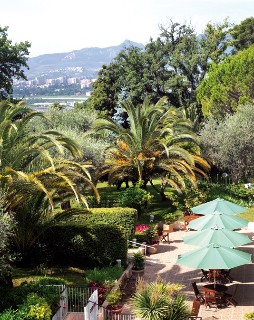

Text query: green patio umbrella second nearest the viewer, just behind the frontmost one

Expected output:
[183,227,251,248]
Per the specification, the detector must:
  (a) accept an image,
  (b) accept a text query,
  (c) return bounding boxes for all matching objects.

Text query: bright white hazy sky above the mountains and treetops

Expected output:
[0,0,254,57]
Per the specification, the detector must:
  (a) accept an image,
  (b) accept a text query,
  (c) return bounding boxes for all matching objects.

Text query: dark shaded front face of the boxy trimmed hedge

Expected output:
[42,223,127,268]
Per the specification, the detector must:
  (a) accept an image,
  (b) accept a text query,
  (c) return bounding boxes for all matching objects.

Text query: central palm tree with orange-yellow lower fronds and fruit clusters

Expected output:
[94,98,209,197]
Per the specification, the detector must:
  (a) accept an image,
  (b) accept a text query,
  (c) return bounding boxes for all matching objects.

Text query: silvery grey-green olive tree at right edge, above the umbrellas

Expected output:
[200,104,254,182]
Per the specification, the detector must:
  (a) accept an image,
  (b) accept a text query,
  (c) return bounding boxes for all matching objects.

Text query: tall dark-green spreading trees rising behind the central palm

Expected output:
[90,21,229,125]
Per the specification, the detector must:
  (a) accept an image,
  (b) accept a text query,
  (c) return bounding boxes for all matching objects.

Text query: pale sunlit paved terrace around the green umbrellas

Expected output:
[124,228,254,320]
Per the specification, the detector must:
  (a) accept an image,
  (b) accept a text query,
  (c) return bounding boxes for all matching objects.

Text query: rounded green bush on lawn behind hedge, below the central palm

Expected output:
[119,187,152,215]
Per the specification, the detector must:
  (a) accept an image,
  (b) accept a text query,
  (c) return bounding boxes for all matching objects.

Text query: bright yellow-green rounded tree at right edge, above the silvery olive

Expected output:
[197,45,254,118]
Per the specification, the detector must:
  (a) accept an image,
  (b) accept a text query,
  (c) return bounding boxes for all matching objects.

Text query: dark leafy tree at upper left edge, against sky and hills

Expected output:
[0,27,31,99]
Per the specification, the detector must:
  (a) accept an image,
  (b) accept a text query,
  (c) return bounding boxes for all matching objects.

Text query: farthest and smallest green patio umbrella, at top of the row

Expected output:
[191,198,247,214]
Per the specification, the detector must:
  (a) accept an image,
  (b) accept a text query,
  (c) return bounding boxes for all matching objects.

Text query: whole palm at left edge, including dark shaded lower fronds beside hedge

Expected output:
[0,101,98,262]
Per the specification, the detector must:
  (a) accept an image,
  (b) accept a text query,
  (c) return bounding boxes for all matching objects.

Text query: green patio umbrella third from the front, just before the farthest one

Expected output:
[188,211,249,231]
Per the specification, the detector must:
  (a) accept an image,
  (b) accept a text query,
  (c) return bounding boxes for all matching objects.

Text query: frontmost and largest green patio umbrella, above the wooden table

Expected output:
[176,243,251,269]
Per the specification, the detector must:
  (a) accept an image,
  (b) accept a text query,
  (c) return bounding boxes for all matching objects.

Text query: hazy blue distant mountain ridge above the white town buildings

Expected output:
[26,40,144,79]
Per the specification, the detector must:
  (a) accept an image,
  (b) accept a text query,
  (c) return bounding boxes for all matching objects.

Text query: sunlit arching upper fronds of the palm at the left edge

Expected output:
[0,101,96,210]
